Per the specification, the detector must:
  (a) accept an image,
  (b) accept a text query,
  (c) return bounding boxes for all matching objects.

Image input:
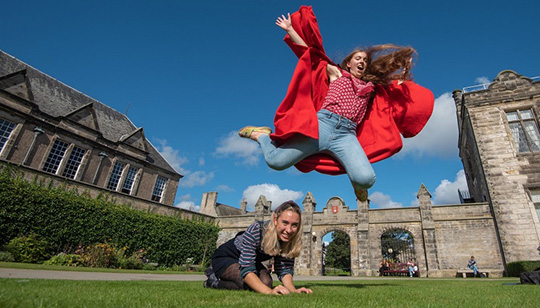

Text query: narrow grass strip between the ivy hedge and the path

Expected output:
[0,262,203,275]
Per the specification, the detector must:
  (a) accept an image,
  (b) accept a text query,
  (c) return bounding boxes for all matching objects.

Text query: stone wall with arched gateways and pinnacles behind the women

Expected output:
[213,185,504,277]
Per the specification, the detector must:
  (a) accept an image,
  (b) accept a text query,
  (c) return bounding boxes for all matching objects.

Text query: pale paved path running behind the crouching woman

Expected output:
[0,268,402,281]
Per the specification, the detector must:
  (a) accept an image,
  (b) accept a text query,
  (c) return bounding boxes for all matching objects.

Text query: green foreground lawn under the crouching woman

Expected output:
[0,278,540,308]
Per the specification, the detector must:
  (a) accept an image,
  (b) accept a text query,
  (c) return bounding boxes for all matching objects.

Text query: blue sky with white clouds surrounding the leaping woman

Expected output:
[0,0,540,210]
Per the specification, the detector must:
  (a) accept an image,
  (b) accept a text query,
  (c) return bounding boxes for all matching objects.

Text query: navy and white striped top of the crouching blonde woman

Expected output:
[234,221,294,280]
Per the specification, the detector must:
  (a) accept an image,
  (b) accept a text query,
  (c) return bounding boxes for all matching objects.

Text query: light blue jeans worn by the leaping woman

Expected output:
[258,109,375,189]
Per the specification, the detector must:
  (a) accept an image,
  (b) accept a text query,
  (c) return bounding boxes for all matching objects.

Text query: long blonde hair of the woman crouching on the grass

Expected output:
[261,201,302,258]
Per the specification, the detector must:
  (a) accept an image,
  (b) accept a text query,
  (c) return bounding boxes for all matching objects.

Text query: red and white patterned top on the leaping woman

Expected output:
[321,70,374,124]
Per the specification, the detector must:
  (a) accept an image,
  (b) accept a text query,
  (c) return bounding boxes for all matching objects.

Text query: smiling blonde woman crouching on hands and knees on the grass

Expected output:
[204,201,312,294]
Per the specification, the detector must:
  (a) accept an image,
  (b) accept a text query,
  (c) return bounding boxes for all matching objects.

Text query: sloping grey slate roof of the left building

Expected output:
[0,50,181,177]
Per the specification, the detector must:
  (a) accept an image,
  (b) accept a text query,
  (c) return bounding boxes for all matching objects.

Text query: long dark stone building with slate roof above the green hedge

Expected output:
[0,50,189,214]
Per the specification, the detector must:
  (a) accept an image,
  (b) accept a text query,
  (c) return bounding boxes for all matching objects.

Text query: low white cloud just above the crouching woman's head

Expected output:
[242,183,304,210]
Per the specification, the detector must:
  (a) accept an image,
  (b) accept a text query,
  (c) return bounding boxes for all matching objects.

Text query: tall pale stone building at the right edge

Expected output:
[453,70,540,262]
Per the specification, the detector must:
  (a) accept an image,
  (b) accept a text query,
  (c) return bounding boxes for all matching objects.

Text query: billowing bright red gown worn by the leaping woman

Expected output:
[270,6,434,175]
